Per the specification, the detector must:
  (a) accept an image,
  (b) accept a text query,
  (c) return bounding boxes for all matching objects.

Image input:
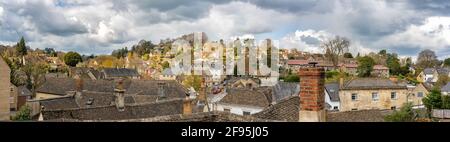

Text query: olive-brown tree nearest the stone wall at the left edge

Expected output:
[22,63,48,97]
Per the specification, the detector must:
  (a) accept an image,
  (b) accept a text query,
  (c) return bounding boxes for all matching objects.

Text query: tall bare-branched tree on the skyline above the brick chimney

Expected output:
[321,36,350,67]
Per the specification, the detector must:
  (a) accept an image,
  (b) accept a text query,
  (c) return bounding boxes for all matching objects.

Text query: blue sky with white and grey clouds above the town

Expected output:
[0,0,450,58]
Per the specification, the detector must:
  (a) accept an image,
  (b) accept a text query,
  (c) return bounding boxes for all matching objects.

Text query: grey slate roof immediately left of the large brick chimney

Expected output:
[272,82,300,103]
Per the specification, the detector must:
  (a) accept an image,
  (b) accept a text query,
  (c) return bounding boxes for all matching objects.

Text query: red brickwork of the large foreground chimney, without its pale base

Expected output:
[298,67,325,111]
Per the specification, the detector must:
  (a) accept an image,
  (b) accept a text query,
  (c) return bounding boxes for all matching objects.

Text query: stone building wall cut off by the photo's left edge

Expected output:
[0,59,11,121]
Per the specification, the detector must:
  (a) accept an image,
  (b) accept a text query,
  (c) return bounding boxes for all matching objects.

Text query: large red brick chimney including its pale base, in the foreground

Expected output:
[298,67,326,122]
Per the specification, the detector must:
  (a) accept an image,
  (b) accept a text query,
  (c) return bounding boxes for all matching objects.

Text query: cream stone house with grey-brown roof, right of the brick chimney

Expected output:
[339,78,413,111]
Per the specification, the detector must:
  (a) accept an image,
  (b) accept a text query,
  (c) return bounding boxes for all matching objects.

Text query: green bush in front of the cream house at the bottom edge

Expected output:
[384,103,416,122]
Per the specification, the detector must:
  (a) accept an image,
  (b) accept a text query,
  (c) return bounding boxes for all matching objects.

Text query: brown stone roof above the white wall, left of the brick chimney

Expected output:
[219,89,270,107]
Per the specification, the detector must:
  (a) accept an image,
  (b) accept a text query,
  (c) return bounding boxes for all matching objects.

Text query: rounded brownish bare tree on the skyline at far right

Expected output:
[417,49,439,68]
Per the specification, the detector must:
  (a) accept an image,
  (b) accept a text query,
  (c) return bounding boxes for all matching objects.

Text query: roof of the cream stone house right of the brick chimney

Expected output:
[342,78,407,90]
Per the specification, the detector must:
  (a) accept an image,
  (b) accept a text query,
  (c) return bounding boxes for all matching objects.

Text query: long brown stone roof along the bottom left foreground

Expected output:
[42,99,183,121]
